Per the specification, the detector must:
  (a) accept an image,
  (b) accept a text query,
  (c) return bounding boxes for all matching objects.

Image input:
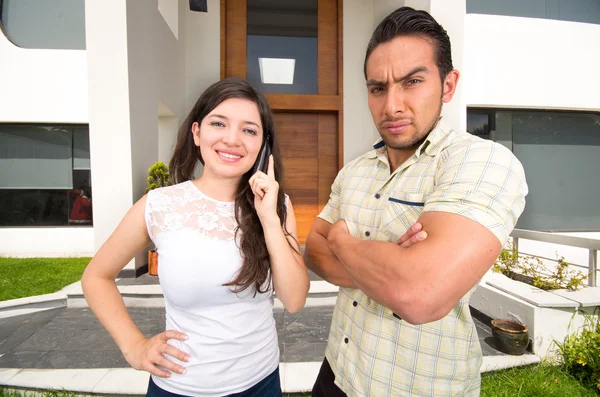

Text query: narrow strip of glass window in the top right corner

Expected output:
[467,0,600,24]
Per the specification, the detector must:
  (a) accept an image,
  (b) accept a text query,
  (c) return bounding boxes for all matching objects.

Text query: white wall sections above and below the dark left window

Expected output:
[0,10,94,256]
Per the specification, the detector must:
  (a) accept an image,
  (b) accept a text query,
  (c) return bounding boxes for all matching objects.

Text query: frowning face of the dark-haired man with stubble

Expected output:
[366,36,458,150]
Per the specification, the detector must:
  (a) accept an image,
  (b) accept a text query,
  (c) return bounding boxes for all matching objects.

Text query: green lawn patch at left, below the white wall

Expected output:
[0,258,91,301]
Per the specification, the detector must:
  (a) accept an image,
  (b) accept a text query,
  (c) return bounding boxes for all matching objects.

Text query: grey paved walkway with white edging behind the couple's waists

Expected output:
[0,275,539,395]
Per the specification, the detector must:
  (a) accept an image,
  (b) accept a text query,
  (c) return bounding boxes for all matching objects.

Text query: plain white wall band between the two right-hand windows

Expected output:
[463,14,600,111]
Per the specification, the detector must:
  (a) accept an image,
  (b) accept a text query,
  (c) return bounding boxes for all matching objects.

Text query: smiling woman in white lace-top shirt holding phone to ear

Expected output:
[82,79,309,397]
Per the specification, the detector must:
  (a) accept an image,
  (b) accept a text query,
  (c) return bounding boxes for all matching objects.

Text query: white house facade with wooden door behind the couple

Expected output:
[0,0,600,275]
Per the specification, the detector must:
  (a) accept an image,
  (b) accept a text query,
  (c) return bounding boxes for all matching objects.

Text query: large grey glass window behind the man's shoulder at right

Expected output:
[467,109,600,232]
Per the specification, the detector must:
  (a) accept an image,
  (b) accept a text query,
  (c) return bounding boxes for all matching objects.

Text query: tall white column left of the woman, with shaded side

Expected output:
[85,0,158,270]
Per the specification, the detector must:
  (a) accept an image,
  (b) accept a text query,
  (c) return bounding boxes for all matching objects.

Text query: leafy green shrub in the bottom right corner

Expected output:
[555,309,600,392]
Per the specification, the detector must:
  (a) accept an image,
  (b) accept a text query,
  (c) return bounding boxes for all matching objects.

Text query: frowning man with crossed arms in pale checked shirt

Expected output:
[305,7,527,397]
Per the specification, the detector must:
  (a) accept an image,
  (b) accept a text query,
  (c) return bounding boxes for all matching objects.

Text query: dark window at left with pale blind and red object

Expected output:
[0,124,93,227]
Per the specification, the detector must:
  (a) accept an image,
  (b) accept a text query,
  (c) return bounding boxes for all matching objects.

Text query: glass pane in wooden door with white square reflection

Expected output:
[246,0,318,94]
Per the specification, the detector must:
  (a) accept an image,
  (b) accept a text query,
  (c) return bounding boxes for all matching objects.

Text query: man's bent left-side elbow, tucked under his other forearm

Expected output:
[304,229,357,288]
